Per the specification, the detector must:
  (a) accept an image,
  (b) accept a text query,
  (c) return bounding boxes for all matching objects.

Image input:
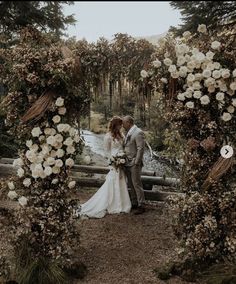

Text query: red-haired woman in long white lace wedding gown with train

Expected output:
[79,116,131,218]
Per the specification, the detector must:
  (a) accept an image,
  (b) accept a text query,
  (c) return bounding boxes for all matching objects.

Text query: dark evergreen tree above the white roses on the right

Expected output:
[170,1,236,35]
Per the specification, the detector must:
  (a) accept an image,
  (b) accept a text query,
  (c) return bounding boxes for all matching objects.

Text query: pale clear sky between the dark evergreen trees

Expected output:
[64,1,181,42]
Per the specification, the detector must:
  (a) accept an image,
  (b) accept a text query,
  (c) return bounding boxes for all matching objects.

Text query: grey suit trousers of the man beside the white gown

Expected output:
[126,165,145,206]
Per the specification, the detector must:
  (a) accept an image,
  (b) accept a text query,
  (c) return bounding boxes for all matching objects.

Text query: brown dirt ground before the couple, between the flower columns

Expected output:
[74,189,198,284]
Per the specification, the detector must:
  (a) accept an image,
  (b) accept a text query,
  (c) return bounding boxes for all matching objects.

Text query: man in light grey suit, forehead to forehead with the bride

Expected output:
[123,115,145,214]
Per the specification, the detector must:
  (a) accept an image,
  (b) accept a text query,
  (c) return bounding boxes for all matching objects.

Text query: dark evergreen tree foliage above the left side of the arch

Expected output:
[0,1,75,36]
